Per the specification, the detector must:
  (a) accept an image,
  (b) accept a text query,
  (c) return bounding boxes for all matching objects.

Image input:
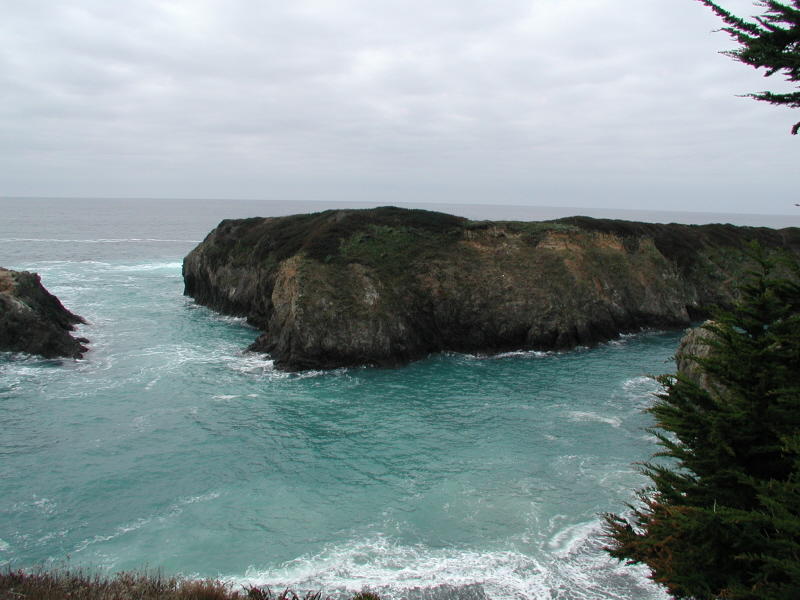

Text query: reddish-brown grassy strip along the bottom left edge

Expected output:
[0,570,380,600]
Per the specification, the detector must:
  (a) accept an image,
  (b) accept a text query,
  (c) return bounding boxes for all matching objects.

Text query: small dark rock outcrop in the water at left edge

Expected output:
[0,267,88,358]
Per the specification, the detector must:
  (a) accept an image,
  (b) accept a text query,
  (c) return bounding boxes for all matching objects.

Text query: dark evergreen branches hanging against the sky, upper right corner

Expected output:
[699,0,800,135]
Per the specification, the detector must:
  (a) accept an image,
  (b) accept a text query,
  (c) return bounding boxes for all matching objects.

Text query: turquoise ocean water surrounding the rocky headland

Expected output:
[0,199,784,600]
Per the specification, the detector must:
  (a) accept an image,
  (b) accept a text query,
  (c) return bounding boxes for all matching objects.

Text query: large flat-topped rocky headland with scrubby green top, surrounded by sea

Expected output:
[183,208,800,370]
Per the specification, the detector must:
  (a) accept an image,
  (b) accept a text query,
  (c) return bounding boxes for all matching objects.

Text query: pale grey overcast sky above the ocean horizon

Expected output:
[0,0,800,214]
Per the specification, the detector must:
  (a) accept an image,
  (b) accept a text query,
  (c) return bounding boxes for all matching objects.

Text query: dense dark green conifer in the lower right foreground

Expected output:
[606,253,800,600]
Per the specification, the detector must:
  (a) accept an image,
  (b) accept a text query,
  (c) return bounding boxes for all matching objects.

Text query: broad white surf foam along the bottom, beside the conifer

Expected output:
[224,521,667,600]
